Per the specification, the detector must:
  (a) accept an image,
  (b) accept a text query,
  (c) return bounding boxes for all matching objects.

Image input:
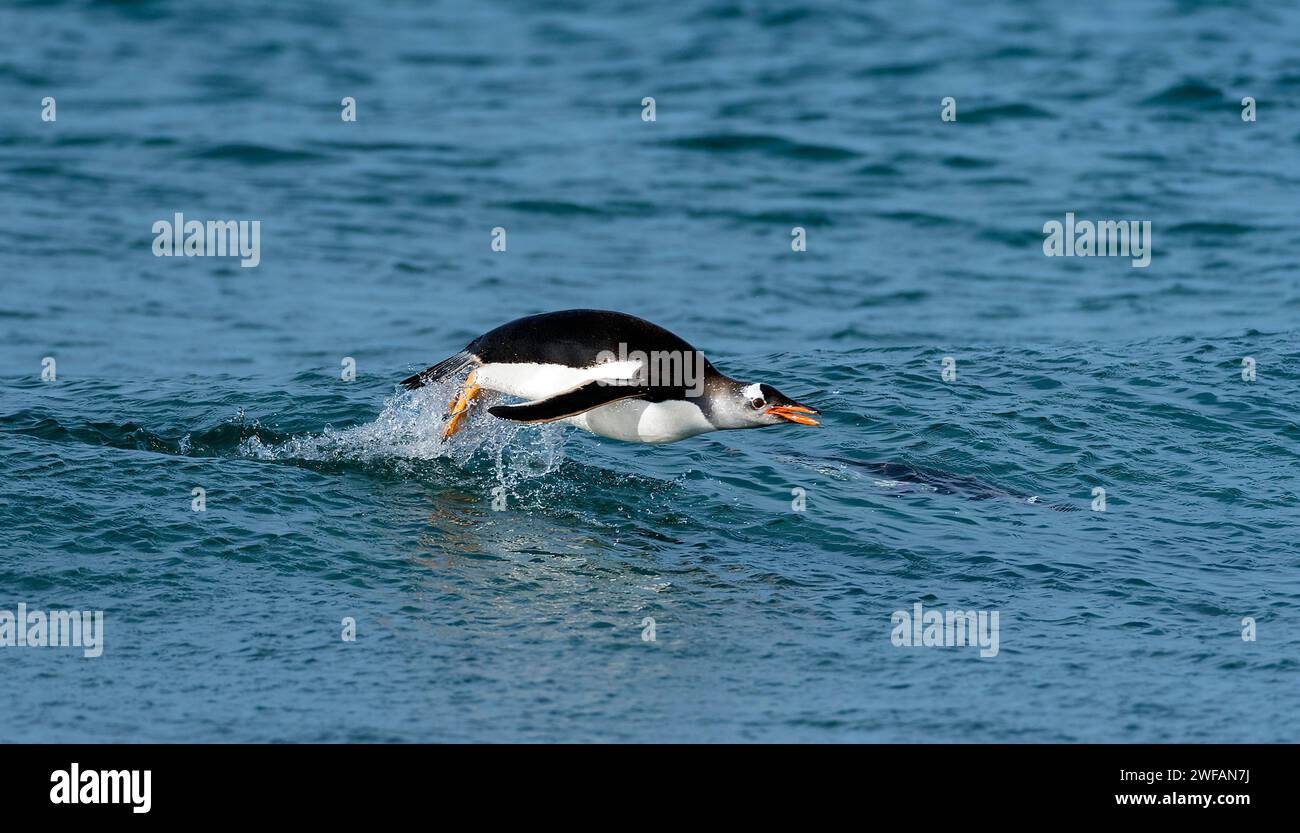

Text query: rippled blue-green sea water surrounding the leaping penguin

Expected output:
[0,0,1300,742]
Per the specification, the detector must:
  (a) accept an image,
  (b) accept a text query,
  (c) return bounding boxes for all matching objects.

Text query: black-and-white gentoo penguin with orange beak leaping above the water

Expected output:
[402,309,818,443]
